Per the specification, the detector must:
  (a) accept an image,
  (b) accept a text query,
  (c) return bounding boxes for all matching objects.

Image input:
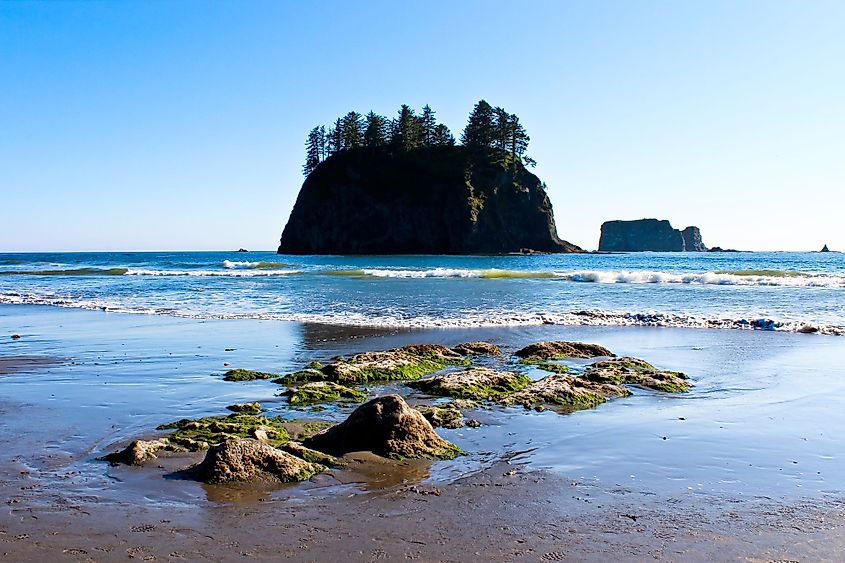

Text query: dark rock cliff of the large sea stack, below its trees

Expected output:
[279,147,581,254]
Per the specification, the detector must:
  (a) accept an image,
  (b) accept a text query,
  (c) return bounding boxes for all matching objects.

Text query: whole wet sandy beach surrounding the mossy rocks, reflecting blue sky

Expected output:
[0,306,845,561]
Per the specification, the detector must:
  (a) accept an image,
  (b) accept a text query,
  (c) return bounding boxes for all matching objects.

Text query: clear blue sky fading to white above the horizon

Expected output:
[0,0,845,251]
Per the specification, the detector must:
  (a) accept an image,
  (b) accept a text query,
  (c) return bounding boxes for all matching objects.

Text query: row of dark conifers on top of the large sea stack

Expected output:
[302,100,536,176]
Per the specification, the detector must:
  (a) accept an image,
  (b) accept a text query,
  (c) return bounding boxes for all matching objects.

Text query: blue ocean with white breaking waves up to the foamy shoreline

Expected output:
[0,252,845,335]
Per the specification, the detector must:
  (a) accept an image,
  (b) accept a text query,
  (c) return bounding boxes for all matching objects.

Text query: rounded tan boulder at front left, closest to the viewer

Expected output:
[188,438,325,483]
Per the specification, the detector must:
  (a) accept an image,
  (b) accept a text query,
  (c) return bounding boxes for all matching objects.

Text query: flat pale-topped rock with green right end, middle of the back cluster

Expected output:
[408,368,531,401]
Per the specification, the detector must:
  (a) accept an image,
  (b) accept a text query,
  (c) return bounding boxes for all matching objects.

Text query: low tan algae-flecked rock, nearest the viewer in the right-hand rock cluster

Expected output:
[499,373,631,411]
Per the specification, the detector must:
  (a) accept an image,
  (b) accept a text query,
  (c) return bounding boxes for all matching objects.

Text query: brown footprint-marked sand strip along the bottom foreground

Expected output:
[0,454,845,561]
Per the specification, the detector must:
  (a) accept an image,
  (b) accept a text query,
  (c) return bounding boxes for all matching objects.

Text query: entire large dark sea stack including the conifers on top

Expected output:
[278,100,583,255]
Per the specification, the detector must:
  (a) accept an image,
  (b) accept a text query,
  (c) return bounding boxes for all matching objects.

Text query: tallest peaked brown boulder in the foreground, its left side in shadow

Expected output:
[303,395,462,459]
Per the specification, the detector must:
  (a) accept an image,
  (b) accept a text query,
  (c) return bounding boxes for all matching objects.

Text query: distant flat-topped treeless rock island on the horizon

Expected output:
[599,219,707,252]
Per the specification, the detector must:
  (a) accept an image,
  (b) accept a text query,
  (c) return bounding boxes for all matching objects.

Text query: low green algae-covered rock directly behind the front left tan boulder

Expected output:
[158,414,290,451]
